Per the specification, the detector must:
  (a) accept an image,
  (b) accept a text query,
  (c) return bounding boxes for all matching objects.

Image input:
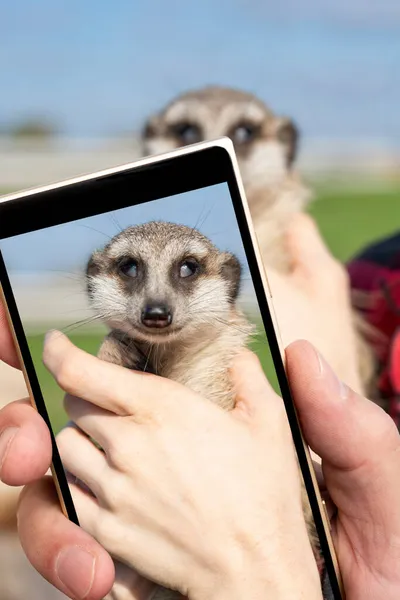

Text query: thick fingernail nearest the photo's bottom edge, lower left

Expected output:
[56,546,96,598]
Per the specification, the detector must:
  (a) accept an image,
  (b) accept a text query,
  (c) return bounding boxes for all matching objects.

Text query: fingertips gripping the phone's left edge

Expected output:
[0,301,114,600]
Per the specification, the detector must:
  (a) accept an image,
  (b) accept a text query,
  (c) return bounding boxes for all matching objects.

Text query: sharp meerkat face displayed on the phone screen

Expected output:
[87,222,241,343]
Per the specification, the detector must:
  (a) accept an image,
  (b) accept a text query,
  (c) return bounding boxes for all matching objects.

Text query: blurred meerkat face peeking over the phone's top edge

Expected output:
[142,87,298,188]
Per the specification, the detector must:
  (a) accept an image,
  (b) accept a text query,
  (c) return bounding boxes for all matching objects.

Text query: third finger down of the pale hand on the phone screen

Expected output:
[56,426,111,496]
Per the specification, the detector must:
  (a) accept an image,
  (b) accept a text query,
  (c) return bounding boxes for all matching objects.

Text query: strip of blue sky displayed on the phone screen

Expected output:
[0,183,250,276]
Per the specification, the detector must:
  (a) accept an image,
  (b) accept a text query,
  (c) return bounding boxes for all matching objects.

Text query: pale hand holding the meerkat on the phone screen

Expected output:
[44,333,321,599]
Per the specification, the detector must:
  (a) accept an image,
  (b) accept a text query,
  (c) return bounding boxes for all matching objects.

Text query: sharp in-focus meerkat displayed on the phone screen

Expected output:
[86,222,321,600]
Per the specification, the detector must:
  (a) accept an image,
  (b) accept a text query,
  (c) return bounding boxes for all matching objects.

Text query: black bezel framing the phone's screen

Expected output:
[0,145,342,600]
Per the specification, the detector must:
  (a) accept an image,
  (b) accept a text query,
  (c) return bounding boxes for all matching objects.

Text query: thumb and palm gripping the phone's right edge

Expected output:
[287,342,400,600]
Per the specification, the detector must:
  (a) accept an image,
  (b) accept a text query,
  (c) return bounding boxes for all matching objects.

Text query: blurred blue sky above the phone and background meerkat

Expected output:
[0,0,400,144]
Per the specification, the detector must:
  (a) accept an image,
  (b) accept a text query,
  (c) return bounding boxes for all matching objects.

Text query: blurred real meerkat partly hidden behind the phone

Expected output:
[141,86,376,398]
